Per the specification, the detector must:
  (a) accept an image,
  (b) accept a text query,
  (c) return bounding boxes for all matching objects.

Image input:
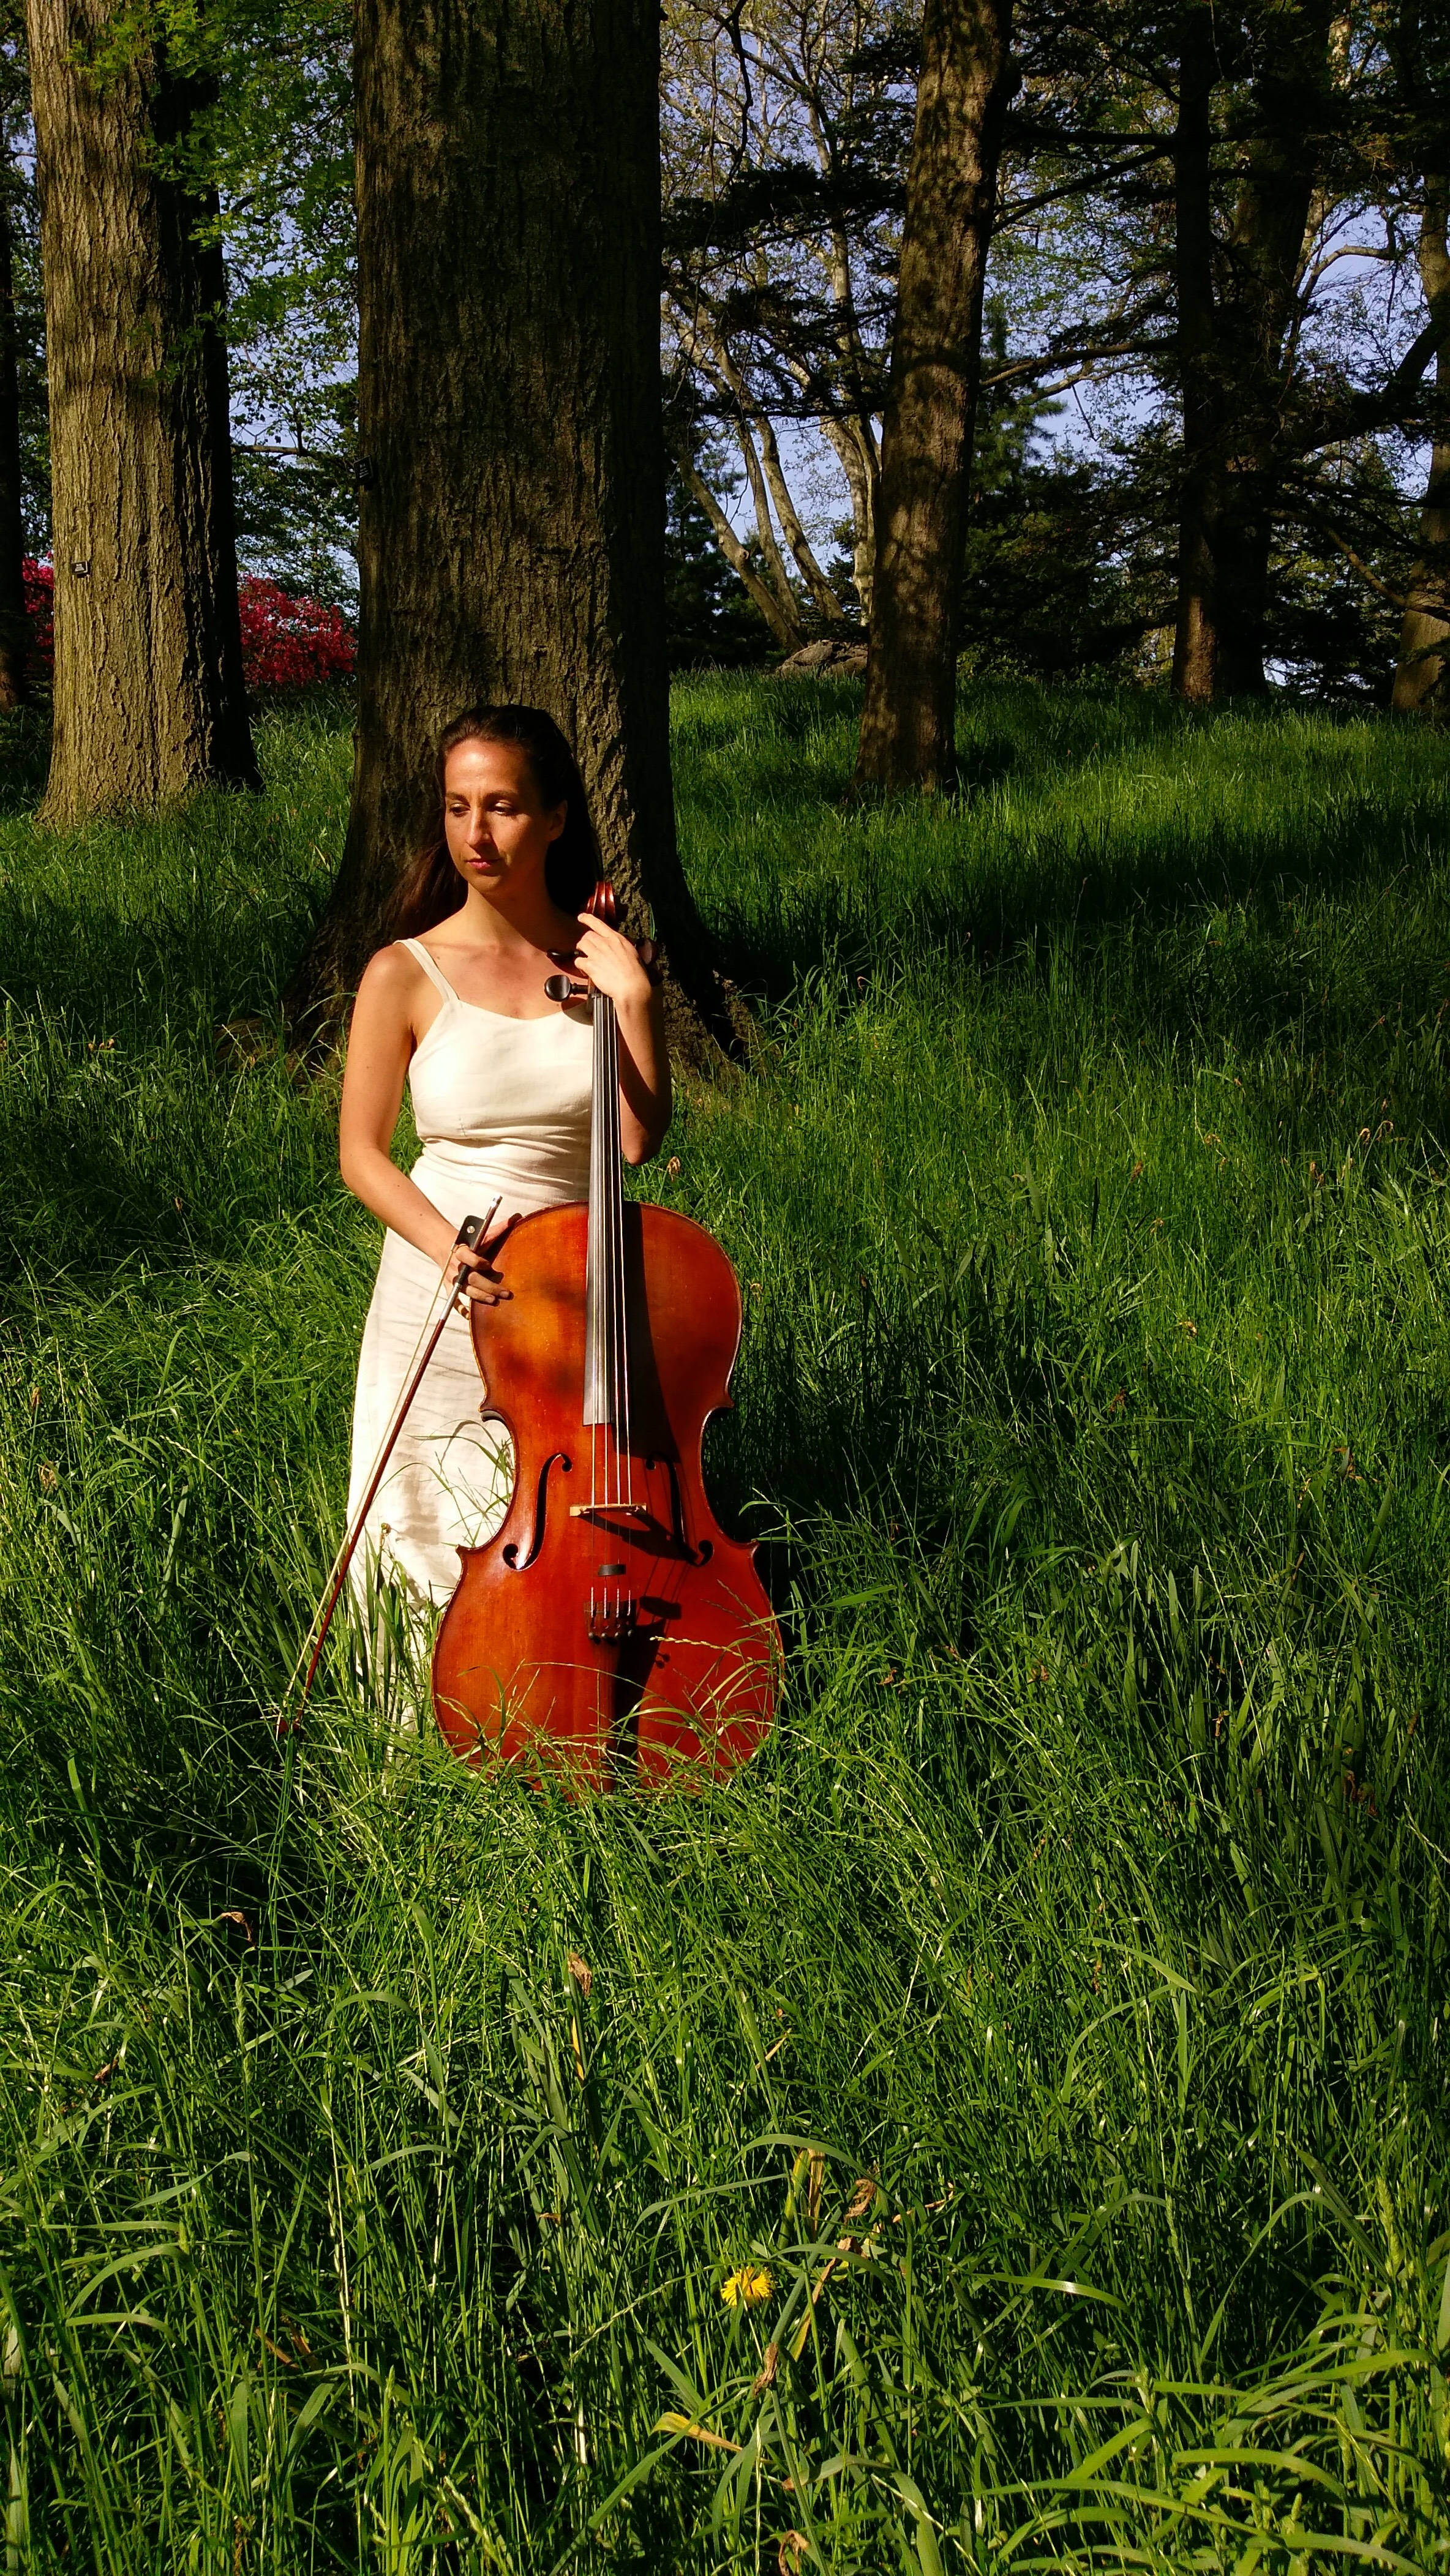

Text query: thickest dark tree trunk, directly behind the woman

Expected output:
[288,0,732,1054]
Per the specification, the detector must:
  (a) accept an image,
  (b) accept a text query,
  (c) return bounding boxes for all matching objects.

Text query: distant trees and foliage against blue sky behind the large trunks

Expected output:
[0,0,1450,703]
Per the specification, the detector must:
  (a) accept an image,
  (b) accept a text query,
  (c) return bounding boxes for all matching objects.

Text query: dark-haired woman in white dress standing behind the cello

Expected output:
[340,706,670,1610]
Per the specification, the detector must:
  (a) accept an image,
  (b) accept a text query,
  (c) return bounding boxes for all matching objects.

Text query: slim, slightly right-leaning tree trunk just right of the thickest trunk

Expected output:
[855,0,1012,791]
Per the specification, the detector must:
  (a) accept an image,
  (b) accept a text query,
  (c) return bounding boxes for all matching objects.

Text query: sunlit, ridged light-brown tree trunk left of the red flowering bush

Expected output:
[26,0,258,825]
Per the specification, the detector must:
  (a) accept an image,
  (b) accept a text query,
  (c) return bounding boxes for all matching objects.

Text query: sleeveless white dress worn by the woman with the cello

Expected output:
[348,940,592,1612]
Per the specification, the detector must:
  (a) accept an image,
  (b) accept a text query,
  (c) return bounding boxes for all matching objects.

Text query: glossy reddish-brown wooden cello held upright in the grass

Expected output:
[433,878,780,1793]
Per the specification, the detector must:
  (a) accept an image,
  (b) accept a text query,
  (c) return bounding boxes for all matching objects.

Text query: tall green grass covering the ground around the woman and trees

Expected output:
[0,680,1450,2576]
